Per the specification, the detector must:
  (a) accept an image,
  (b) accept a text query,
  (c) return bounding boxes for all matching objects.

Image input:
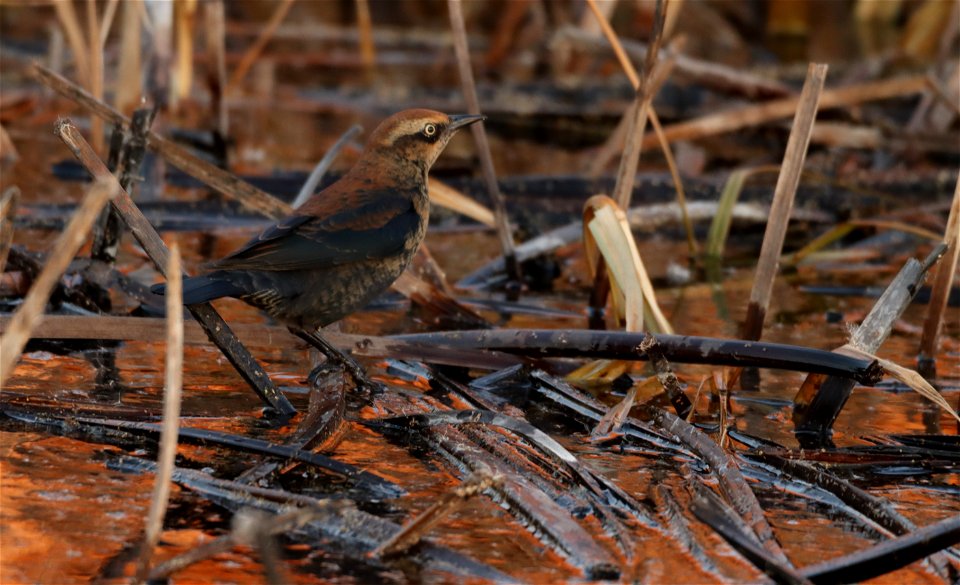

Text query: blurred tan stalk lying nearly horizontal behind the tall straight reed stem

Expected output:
[643,75,927,147]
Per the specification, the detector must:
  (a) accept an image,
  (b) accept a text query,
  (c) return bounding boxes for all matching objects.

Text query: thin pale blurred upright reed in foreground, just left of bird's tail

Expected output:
[137,243,183,582]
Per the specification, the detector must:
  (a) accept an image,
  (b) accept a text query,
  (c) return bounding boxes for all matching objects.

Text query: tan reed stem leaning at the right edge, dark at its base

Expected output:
[918,177,960,380]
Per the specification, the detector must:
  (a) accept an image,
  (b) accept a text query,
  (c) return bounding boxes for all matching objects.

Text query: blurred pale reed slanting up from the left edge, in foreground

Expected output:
[0,180,119,386]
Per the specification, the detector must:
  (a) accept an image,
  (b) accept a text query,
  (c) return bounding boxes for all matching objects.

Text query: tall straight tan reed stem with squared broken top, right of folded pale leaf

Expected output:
[741,63,827,341]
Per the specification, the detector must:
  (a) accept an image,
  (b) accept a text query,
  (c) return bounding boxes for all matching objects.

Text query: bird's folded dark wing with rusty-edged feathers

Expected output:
[212,193,420,271]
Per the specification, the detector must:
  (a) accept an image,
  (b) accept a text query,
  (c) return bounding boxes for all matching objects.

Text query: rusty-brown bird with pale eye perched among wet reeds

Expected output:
[151,109,485,330]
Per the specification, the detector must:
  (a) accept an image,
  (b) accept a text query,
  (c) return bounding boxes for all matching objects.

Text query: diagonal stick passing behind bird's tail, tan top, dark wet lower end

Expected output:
[56,120,296,416]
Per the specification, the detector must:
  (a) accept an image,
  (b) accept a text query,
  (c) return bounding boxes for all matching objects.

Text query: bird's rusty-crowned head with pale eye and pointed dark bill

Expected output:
[362,110,484,179]
